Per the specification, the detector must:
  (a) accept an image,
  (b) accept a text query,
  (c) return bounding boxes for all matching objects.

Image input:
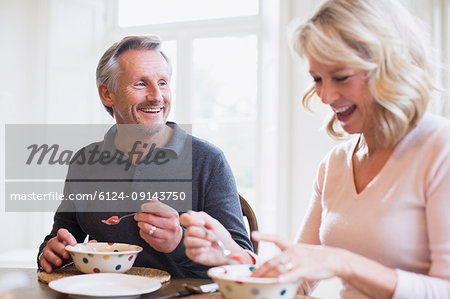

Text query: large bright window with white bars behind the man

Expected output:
[109,0,277,225]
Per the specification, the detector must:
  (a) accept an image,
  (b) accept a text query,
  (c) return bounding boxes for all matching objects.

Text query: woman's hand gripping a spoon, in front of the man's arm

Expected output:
[180,211,253,266]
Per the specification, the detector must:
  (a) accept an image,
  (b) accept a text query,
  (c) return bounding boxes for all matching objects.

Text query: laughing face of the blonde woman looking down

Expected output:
[308,55,374,134]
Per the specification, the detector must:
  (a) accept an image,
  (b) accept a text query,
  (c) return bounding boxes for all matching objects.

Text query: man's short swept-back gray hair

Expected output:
[96,35,172,117]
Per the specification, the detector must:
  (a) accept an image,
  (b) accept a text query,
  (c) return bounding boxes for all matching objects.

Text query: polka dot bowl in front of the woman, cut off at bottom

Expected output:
[208,265,300,299]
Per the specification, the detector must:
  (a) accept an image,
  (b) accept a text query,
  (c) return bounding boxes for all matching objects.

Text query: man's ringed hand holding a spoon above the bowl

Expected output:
[134,200,183,253]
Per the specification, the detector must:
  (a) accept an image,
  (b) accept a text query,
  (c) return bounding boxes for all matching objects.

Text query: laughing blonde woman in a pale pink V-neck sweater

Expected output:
[180,0,450,298]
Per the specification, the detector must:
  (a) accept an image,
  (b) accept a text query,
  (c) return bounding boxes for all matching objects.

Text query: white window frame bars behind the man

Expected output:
[104,0,284,239]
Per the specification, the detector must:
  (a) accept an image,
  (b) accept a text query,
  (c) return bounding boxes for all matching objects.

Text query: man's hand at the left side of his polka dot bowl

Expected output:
[39,228,77,273]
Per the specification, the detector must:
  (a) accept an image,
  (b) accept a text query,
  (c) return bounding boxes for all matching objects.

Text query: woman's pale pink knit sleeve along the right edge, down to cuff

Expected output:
[393,127,450,299]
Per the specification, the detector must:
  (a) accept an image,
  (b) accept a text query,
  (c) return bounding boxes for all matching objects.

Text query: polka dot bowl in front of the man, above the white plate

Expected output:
[66,243,142,273]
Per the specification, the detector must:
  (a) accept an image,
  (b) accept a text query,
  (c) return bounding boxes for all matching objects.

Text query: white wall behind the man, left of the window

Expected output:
[0,0,111,267]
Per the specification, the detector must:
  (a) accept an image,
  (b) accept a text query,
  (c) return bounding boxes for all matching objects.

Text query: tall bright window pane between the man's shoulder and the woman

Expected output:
[192,35,258,198]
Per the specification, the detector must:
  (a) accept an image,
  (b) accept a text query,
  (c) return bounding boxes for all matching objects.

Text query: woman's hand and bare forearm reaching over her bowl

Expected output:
[252,232,397,298]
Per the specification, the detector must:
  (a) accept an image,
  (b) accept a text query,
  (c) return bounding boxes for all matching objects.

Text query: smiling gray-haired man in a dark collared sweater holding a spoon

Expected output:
[38,36,252,277]
